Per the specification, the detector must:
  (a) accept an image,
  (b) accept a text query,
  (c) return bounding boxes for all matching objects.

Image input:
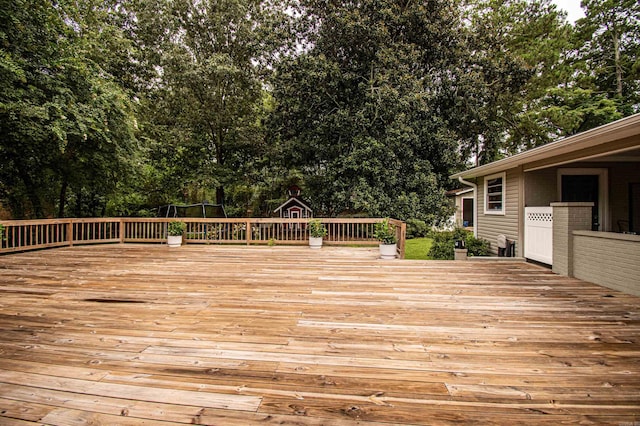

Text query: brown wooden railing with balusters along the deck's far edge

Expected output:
[0,218,406,258]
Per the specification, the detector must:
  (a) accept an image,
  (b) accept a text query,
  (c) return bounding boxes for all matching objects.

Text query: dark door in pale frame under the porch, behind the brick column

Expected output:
[558,169,609,231]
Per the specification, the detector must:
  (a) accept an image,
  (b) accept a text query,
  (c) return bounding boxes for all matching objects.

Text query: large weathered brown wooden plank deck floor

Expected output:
[0,244,640,426]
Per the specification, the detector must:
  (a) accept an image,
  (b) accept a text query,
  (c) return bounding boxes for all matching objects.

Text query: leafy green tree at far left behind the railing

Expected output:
[0,0,135,218]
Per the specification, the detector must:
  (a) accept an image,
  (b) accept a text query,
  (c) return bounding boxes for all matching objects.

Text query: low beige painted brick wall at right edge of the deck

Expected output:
[573,231,640,296]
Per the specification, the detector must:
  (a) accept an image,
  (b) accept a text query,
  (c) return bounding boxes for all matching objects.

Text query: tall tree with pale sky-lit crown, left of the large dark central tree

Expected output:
[138,0,296,209]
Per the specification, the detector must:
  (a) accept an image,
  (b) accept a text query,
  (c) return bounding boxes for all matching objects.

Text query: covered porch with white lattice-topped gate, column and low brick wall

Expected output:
[524,147,640,295]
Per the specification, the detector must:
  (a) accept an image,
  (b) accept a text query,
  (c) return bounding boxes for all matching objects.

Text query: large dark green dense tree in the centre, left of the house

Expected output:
[270,0,464,223]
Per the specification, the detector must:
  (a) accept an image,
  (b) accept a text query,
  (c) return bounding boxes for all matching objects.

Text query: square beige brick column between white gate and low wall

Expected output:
[551,202,593,277]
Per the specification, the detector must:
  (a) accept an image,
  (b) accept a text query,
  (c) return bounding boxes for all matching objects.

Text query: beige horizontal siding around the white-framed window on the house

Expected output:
[478,169,523,254]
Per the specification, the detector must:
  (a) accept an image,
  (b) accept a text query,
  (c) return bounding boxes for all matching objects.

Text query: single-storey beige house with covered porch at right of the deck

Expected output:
[451,114,640,295]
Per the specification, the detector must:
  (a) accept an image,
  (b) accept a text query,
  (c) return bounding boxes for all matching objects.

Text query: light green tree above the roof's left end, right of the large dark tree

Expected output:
[459,0,571,158]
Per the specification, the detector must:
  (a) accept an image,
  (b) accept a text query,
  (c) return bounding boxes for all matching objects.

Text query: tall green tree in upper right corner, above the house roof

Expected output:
[523,0,640,141]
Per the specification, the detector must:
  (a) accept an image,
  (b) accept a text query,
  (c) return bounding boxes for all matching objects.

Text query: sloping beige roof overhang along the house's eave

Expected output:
[450,114,640,179]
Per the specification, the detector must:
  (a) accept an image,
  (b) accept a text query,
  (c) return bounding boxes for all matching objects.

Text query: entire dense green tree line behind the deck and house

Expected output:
[0,0,640,220]
